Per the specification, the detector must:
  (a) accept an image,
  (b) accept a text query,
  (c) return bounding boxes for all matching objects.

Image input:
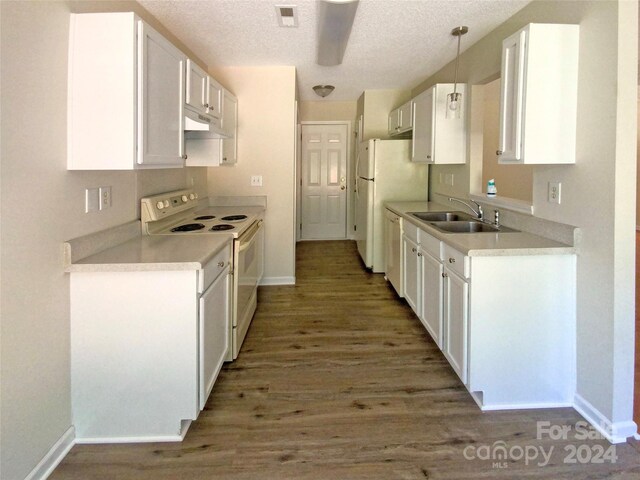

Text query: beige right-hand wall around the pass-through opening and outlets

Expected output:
[413,0,638,436]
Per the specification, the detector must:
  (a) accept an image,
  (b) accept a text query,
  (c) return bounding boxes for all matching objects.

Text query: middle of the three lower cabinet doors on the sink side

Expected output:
[420,251,444,350]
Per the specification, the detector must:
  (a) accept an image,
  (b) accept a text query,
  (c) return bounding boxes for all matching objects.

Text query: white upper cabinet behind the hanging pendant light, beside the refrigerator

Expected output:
[411,83,467,164]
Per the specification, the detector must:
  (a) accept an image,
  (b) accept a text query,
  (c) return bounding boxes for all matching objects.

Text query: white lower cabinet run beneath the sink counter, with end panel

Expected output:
[403,221,576,410]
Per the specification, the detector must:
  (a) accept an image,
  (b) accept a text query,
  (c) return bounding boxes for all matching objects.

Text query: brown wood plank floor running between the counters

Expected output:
[51,241,640,480]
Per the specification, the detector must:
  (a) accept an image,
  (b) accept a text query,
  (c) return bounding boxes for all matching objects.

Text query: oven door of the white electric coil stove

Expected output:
[232,220,264,359]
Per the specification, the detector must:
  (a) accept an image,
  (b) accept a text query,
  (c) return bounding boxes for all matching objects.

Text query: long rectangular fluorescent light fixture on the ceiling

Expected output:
[316,0,358,67]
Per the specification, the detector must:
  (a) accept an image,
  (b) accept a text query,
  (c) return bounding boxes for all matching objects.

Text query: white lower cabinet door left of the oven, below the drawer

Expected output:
[199,268,231,410]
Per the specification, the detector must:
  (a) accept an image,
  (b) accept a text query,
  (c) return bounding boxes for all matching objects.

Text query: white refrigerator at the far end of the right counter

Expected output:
[354,139,428,272]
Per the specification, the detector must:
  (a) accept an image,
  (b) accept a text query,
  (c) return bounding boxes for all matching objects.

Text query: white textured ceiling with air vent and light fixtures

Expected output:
[138,0,530,101]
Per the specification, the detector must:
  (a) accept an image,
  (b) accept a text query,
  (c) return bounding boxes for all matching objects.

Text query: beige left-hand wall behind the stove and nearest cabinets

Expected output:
[0,1,206,480]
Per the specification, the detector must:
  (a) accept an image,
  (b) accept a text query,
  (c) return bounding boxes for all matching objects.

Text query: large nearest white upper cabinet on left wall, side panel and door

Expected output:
[67,13,186,170]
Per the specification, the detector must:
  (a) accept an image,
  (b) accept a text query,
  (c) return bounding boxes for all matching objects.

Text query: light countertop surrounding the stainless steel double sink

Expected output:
[385,202,576,257]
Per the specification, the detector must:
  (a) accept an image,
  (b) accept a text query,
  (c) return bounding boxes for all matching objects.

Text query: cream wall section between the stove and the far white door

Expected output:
[208,67,296,283]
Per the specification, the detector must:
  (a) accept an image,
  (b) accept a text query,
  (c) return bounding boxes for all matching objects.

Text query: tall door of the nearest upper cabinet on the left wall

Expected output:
[137,21,185,168]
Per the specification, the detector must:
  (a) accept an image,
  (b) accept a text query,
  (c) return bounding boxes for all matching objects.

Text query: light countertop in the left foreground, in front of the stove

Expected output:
[66,234,233,272]
